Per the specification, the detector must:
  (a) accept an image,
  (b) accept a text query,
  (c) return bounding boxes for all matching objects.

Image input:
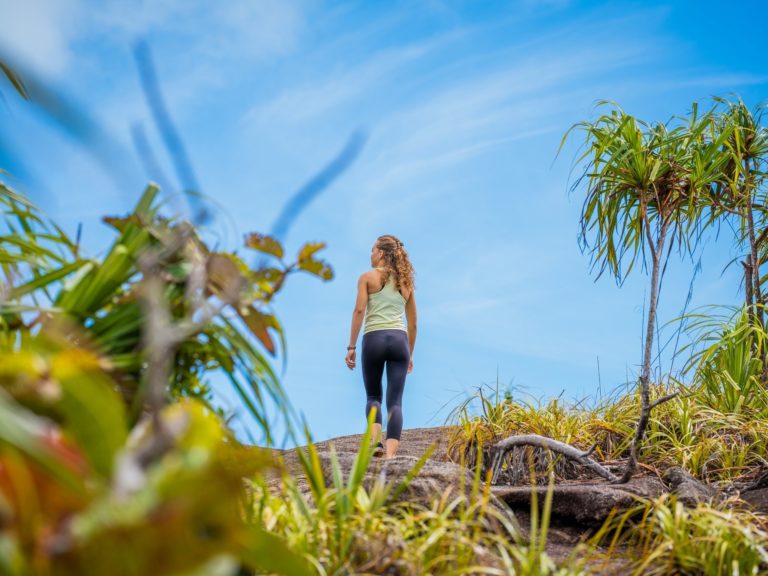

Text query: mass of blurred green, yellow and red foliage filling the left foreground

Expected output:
[0,179,332,575]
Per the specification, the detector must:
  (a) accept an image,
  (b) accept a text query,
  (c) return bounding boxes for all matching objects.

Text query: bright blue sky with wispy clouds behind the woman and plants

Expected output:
[0,0,768,448]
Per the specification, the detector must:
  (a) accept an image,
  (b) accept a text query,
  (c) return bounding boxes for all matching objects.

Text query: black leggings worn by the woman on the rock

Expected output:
[363,329,411,440]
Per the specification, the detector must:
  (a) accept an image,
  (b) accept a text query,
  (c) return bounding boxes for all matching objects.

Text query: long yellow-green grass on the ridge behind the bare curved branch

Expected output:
[448,380,768,485]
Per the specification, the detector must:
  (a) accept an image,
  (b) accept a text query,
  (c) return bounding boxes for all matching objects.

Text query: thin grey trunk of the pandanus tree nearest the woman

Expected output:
[617,221,669,484]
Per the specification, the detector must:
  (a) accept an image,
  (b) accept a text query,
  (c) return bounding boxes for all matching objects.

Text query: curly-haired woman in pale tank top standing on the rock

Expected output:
[346,234,416,459]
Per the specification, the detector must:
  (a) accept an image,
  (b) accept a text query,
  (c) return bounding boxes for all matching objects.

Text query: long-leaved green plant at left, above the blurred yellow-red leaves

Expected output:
[0,183,333,443]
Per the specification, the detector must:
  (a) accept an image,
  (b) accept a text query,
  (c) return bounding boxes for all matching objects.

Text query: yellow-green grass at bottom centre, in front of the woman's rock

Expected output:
[249,420,583,576]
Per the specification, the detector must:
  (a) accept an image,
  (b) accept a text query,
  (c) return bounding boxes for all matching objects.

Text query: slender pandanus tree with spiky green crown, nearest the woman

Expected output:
[563,102,728,482]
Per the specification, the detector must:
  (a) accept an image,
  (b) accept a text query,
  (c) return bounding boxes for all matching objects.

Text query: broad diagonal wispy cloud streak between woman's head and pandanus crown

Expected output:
[353,36,649,219]
